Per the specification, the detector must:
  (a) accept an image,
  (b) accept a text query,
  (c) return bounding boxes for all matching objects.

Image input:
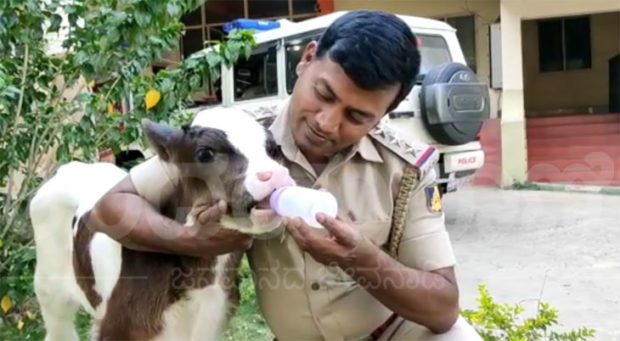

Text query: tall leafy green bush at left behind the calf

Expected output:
[0,0,255,339]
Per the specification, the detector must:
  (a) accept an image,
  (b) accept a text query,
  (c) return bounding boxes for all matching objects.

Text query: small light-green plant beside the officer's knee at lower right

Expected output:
[462,285,595,341]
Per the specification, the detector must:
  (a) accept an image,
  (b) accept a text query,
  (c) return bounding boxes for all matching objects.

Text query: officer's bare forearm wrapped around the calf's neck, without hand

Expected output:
[87,193,196,256]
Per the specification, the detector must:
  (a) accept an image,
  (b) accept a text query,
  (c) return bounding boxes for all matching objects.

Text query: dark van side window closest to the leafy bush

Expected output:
[234,44,278,100]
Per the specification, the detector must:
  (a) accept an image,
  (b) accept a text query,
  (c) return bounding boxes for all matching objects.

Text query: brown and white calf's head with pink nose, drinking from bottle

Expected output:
[144,108,294,234]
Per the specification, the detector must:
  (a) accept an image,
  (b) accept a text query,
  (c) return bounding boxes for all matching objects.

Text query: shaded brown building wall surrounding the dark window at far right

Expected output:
[522,12,620,116]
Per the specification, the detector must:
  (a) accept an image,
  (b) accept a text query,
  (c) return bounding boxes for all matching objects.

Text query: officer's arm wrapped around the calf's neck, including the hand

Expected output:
[86,176,252,257]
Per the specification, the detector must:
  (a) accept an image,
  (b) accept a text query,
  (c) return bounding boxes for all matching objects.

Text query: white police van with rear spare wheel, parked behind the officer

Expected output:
[194,12,490,193]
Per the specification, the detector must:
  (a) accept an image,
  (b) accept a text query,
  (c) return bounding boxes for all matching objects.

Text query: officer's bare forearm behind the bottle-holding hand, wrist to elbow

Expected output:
[341,245,458,333]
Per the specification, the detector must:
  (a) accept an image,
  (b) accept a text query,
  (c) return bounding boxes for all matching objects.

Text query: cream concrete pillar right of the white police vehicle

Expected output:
[500,0,527,187]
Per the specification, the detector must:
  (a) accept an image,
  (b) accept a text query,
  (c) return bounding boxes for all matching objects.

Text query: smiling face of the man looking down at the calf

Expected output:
[289,42,400,163]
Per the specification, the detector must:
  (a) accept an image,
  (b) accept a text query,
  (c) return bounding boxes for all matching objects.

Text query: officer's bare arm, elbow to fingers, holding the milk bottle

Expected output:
[286,214,459,333]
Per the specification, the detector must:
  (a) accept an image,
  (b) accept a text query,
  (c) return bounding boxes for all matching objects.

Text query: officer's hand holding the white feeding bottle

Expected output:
[285,213,377,267]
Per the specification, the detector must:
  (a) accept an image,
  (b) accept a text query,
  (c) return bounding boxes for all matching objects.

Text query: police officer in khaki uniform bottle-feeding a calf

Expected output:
[90,11,480,341]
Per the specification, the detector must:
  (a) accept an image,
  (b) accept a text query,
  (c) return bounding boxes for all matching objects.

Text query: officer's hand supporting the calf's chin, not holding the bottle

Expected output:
[188,200,254,256]
